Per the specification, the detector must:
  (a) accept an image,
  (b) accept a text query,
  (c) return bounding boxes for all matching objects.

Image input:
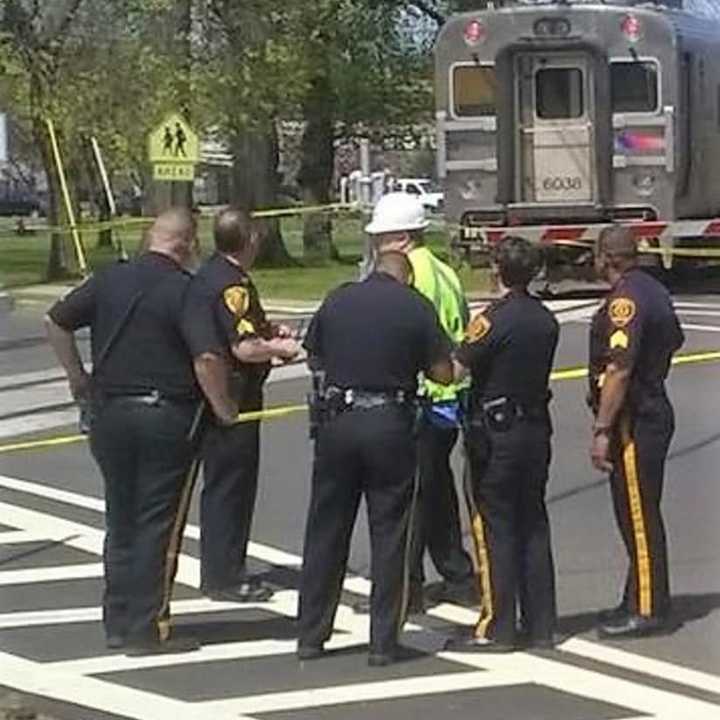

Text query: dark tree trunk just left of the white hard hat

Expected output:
[298,74,339,262]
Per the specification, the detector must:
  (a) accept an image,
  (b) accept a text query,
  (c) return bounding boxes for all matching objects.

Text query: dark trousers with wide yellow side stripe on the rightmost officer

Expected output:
[610,398,675,617]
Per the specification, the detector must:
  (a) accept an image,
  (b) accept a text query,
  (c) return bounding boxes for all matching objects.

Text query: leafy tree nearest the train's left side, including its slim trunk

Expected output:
[298,0,442,260]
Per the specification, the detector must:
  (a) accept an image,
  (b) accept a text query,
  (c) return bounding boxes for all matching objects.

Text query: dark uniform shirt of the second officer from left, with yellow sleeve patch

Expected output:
[185,253,272,394]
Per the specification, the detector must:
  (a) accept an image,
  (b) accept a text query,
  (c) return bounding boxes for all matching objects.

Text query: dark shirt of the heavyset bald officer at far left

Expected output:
[49,252,199,399]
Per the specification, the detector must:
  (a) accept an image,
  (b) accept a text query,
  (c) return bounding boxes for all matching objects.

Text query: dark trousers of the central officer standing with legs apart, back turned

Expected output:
[299,406,416,653]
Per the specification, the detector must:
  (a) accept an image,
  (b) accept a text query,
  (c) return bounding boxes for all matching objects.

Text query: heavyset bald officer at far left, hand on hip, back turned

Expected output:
[46,209,231,655]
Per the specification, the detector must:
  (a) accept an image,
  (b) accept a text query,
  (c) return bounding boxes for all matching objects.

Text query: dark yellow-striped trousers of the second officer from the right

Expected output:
[467,419,557,644]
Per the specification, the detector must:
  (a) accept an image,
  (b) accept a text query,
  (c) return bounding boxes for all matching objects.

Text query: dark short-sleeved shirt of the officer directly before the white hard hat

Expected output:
[304,273,450,392]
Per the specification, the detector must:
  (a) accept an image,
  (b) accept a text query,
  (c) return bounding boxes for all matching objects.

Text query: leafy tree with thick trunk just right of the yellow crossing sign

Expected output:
[201,0,307,265]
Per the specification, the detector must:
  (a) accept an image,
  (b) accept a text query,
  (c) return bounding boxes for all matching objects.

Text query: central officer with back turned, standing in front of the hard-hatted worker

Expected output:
[298,253,452,666]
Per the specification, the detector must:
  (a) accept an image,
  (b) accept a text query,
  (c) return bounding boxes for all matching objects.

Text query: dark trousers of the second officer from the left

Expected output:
[200,421,260,591]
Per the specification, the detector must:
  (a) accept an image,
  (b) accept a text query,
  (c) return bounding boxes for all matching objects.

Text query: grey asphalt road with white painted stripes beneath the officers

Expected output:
[0,296,720,720]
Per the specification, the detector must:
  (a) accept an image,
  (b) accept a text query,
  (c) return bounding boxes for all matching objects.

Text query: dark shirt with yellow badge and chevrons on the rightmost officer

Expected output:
[590,268,684,405]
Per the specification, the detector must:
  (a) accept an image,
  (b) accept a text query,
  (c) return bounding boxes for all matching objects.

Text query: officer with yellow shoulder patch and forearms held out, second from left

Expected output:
[186,209,299,602]
